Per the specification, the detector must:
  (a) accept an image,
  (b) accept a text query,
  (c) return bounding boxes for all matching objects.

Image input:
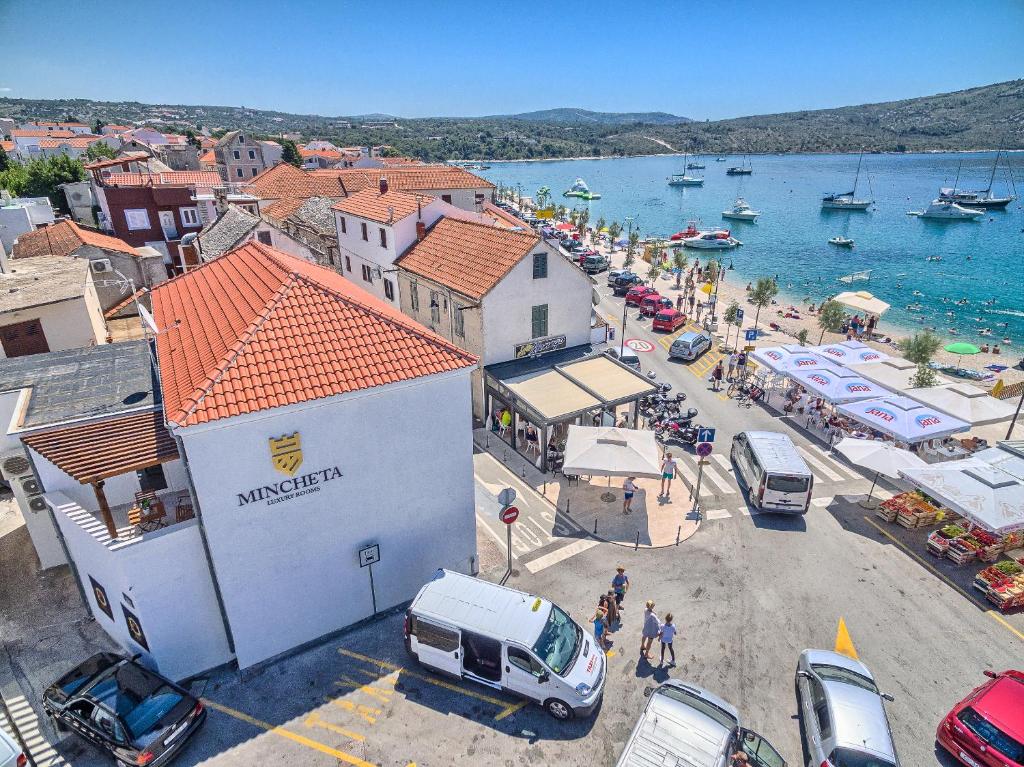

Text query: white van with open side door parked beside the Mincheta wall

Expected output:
[406,569,605,719]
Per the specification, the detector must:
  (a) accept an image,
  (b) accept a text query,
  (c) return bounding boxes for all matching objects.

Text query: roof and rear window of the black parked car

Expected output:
[89,664,183,740]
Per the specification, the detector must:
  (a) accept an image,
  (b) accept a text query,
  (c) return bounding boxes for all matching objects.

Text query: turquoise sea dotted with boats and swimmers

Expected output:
[479,153,1024,344]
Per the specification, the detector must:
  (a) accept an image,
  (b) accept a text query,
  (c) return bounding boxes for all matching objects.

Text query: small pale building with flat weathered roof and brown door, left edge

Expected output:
[0,256,106,358]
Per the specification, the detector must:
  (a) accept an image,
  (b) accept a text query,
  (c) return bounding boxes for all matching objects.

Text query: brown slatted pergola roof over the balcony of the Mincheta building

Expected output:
[22,411,178,484]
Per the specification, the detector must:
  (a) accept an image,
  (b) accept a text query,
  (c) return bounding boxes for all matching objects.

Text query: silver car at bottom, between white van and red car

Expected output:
[797,650,899,767]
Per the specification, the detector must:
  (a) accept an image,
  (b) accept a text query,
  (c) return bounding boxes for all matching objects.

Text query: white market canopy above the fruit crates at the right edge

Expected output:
[900,445,1024,535]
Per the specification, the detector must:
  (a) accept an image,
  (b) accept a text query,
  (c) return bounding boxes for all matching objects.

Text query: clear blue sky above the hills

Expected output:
[0,0,1024,119]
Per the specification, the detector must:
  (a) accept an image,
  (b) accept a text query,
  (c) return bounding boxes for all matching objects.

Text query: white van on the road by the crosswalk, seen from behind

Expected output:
[730,431,814,514]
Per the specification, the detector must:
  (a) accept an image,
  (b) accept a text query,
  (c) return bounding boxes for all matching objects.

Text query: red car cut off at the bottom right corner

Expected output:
[935,670,1024,767]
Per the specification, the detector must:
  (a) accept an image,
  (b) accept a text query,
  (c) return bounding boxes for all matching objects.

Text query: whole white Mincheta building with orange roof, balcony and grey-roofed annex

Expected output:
[0,243,478,678]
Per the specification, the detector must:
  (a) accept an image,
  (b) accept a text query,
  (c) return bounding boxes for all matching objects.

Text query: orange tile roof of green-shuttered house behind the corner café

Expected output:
[397,217,541,299]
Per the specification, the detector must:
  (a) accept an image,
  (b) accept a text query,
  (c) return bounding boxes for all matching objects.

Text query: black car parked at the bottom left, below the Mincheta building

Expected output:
[43,652,206,767]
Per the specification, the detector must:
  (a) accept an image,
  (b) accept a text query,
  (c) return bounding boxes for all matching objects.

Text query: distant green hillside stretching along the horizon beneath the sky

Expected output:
[0,80,1024,162]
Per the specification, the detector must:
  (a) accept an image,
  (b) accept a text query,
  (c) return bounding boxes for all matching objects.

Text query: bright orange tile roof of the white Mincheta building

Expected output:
[153,242,476,426]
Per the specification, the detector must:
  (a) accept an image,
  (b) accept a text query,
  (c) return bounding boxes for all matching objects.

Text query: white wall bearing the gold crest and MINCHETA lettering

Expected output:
[177,369,476,668]
